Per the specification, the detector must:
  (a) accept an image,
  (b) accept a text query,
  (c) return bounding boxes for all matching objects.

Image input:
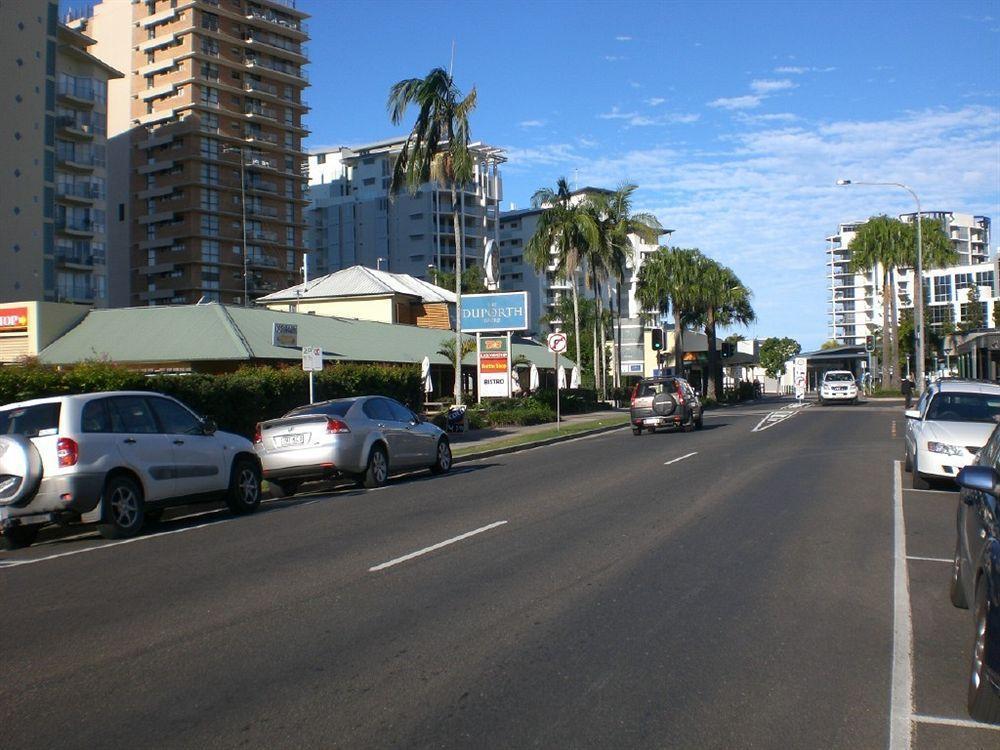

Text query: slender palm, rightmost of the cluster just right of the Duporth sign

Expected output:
[591,183,663,396]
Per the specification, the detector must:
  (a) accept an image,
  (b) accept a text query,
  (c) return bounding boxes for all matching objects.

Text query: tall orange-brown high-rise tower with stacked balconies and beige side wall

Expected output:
[81,0,307,305]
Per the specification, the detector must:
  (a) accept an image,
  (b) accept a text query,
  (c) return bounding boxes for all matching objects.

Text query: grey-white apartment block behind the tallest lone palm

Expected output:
[306,138,506,279]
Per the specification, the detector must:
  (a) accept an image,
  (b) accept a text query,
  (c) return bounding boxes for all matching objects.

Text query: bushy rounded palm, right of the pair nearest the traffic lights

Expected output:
[693,256,756,400]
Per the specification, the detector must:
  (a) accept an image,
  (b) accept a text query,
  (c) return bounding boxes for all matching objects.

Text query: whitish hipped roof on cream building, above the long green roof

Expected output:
[257,266,455,304]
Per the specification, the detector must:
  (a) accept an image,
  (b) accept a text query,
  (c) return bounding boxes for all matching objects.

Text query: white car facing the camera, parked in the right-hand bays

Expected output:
[905,379,1000,489]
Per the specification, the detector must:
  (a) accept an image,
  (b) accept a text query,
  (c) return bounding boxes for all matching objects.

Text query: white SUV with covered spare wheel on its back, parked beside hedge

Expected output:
[0,391,261,549]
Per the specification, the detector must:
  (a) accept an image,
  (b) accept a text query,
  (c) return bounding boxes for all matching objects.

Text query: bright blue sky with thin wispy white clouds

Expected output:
[299,0,1000,348]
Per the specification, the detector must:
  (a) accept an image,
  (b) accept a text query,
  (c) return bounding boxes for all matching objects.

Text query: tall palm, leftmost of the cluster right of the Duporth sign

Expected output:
[524,177,600,376]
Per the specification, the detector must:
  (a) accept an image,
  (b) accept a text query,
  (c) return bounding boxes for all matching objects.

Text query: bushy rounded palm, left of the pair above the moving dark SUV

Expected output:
[635,247,701,375]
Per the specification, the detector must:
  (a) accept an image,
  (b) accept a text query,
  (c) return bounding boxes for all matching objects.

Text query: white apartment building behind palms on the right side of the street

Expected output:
[826,211,1000,344]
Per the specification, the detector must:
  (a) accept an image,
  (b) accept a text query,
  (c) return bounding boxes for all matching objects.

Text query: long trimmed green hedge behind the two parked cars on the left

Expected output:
[0,362,420,437]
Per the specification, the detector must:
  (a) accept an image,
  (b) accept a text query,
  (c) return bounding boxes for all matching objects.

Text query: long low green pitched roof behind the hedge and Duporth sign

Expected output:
[39,303,573,368]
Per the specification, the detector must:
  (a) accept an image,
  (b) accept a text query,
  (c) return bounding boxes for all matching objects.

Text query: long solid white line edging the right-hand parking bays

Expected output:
[889,461,913,750]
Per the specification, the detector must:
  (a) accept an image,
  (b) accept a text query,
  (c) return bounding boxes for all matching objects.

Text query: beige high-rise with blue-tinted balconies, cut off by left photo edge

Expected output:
[0,2,121,306]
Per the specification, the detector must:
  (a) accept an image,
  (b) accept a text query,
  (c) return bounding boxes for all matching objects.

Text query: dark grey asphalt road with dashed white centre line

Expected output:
[0,406,1000,748]
